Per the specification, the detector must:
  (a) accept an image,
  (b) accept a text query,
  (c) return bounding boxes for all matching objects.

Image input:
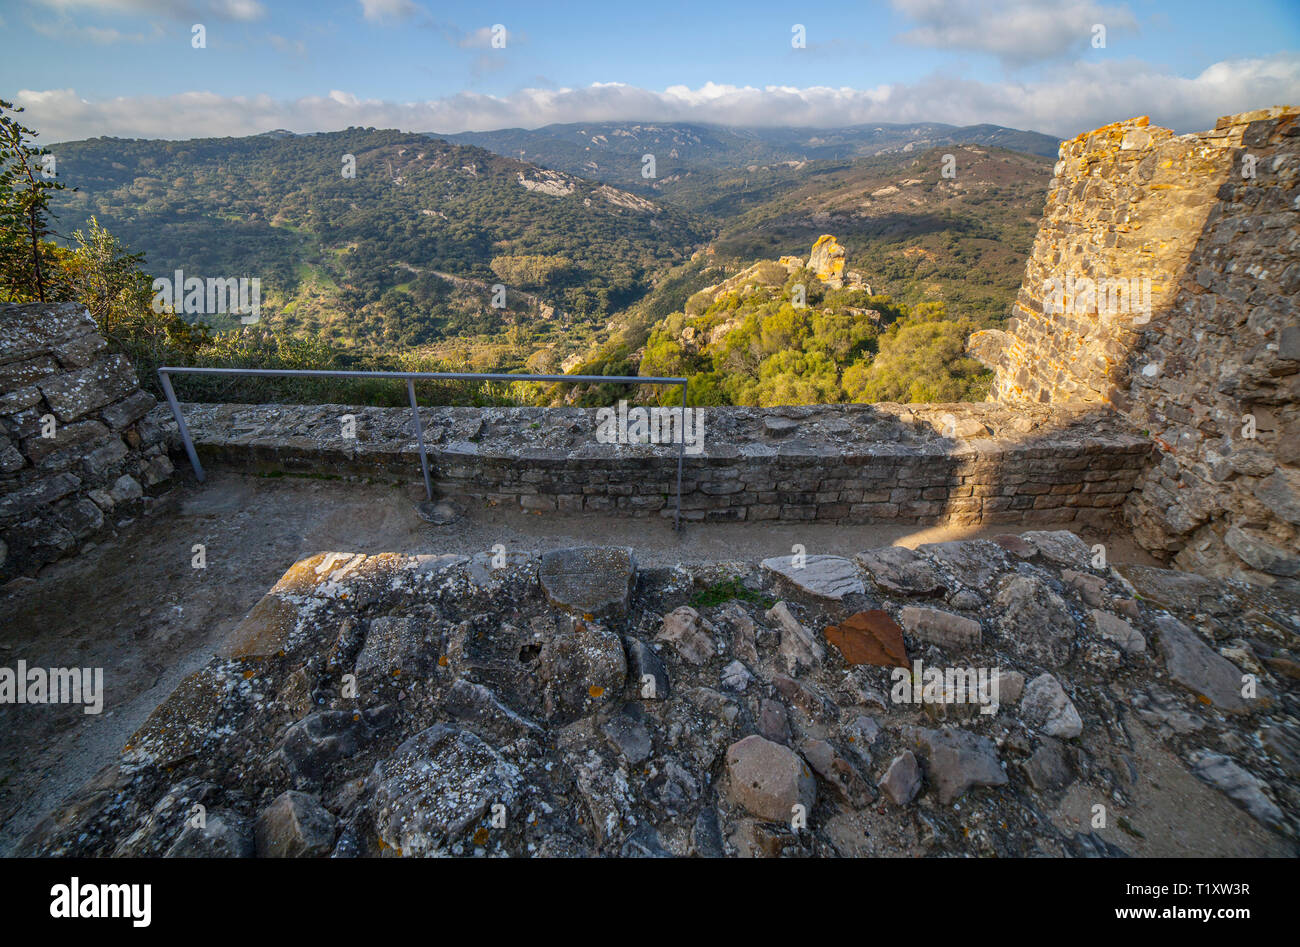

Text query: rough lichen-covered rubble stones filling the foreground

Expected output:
[18,532,1300,857]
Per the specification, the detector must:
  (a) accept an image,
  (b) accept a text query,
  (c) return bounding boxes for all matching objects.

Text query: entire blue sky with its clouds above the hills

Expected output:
[0,0,1300,142]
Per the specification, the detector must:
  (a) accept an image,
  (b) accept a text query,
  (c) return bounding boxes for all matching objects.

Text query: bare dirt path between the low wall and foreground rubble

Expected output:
[0,471,1149,855]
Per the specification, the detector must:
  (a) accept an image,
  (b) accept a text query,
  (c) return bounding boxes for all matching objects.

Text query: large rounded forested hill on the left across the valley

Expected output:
[55,129,707,361]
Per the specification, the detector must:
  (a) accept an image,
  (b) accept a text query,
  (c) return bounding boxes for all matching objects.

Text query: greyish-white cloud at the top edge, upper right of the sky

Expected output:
[893,0,1138,65]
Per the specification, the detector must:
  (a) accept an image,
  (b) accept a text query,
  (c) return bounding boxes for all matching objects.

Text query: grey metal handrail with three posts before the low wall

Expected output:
[159,366,688,529]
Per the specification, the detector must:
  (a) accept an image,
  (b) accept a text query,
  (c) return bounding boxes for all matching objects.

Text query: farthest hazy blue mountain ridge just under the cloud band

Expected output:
[429,122,1061,189]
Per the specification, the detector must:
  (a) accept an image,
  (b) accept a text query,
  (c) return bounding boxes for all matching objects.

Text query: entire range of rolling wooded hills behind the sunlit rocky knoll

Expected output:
[55,125,1054,371]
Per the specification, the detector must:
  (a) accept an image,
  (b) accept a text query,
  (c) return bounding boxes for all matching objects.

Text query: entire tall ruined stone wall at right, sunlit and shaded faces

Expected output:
[969,108,1300,584]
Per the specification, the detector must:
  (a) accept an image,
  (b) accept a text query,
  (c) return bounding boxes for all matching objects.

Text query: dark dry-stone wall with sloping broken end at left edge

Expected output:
[0,303,172,580]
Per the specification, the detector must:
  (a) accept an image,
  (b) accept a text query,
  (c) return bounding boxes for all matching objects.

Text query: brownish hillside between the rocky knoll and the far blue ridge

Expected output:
[691,146,1052,316]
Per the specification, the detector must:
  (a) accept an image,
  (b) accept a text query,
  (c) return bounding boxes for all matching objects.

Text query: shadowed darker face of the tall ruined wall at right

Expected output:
[1125,112,1300,589]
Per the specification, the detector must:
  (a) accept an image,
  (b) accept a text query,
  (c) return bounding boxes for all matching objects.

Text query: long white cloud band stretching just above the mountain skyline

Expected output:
[17,53,1300,142]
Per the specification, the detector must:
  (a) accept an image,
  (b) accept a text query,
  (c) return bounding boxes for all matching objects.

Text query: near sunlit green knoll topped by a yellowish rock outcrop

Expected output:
[626,235,988,407]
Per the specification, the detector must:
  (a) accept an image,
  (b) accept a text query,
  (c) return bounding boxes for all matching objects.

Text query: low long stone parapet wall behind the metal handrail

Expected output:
[155,403,1151,524]
